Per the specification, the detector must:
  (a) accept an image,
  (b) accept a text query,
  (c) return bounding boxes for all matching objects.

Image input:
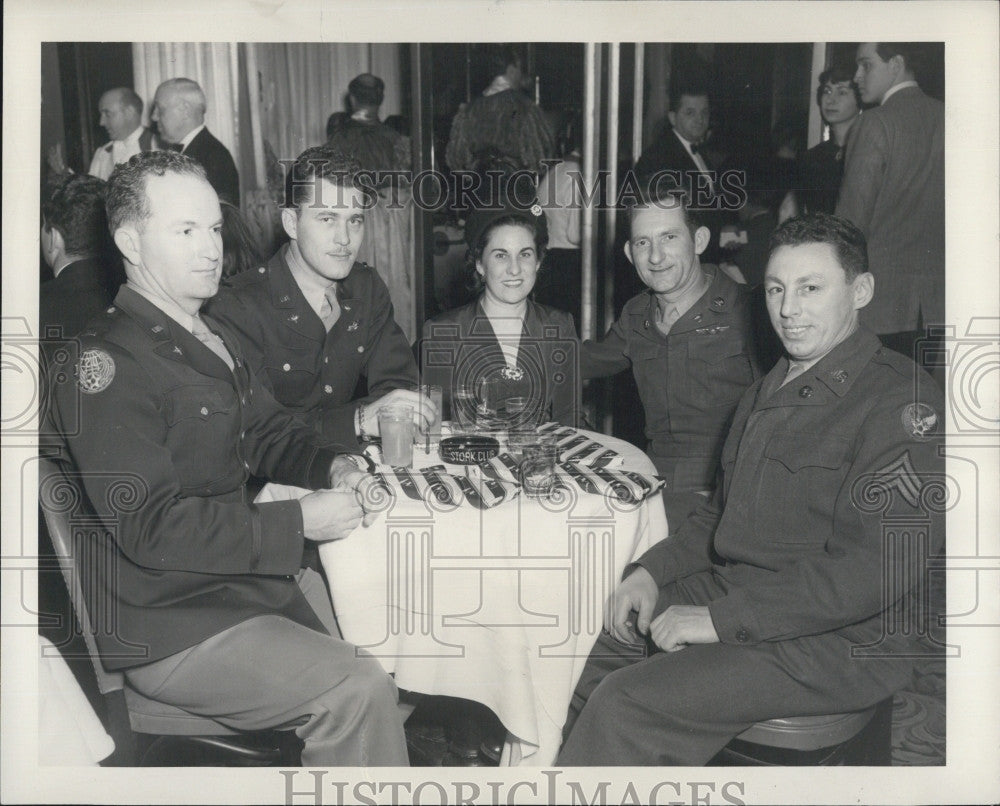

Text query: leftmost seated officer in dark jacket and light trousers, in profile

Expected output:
[53,151,407,766]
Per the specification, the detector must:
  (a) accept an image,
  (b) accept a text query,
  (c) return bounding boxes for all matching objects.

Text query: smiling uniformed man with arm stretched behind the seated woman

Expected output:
[581,183,759,529]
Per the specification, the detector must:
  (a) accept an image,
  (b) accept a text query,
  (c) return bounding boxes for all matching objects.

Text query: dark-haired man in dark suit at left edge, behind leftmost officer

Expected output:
[38,174,116,339]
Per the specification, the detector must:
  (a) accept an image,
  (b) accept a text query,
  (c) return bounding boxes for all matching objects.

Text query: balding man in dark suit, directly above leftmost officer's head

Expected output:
[149,78,240,207]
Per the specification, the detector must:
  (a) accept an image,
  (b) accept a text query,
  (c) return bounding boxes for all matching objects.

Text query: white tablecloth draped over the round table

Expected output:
[258,432,667,765]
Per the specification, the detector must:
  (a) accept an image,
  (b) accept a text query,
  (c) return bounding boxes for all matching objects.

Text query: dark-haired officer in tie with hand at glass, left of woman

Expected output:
[209,146,432,447]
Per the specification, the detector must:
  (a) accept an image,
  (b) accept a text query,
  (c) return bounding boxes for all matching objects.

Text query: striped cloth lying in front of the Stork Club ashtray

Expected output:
[374,465,521,509]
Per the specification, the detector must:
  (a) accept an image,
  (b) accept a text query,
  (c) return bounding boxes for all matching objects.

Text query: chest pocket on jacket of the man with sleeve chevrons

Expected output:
[755,432,851,548]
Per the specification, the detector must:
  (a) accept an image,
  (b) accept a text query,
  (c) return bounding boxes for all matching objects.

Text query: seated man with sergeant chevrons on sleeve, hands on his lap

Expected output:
[559,213,945,766]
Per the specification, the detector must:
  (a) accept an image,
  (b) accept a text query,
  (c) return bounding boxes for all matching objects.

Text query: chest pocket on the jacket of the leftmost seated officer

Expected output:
[164,384,241,493]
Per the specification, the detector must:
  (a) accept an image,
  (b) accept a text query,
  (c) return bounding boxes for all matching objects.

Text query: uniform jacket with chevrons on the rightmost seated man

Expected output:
[626,330,945,649]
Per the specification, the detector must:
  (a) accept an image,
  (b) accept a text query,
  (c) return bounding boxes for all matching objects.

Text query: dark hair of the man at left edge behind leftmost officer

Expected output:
[42,174,108,257]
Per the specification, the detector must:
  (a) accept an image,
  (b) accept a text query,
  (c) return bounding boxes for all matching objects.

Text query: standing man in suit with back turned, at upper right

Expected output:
[837,42,944,357]
